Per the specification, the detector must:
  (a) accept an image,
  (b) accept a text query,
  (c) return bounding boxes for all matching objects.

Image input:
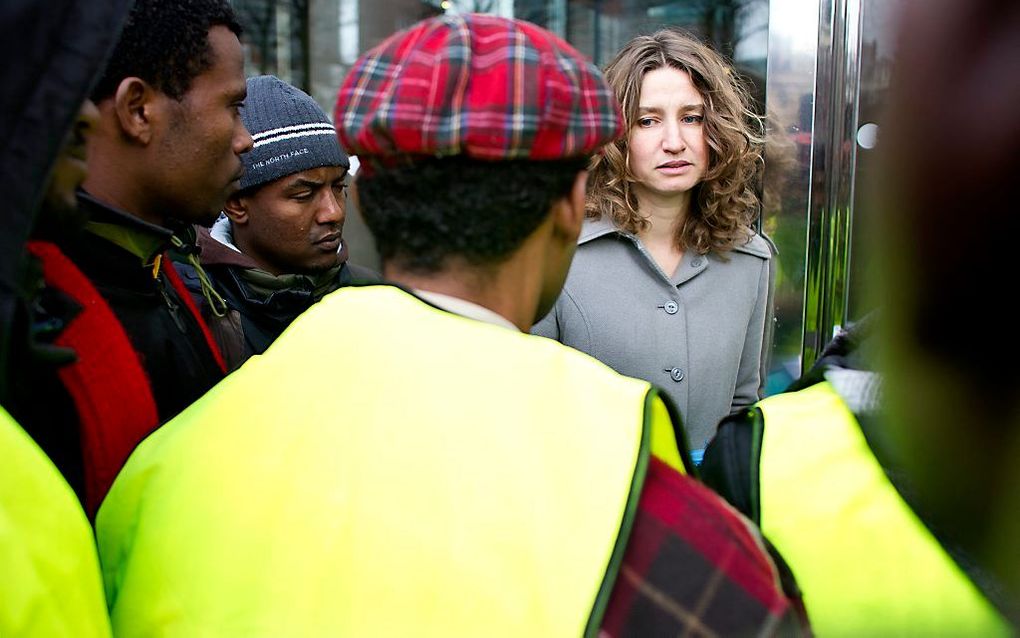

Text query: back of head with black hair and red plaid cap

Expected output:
[335,14,621,274]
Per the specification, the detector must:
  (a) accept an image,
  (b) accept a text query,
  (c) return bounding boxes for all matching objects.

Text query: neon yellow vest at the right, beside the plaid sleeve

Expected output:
[759,383,1010,638]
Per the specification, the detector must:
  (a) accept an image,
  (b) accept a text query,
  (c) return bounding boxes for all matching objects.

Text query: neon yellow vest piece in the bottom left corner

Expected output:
[0,407,110,638]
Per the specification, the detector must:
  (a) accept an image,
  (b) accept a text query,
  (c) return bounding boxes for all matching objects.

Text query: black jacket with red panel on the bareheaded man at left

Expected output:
[9,193,224,516]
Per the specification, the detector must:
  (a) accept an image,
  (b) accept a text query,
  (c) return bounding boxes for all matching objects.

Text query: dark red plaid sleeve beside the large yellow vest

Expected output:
[599,457,810,638]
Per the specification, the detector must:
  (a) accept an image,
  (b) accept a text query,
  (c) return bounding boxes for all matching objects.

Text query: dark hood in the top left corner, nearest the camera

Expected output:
[0,0,133,391]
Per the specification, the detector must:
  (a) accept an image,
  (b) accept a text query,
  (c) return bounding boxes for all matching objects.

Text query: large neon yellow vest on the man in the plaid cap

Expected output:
[98,286,678,637]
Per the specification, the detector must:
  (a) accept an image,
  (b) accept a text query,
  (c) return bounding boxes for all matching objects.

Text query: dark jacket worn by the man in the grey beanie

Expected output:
[174,217,379,371]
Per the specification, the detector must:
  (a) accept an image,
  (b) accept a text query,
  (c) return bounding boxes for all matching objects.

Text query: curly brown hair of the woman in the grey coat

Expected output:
[585,29,764,254]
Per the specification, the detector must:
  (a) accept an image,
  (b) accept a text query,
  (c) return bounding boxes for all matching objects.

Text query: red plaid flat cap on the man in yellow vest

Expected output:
[334,14,623,160]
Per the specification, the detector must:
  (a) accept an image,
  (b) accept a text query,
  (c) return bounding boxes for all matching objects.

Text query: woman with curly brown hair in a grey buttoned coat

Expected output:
[532,29,774,461]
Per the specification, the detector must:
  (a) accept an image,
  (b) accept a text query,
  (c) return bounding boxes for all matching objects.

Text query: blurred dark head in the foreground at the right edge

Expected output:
[878,0,1020,592]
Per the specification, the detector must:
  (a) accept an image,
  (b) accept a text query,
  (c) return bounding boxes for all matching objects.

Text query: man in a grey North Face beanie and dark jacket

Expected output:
[177,76,377,370]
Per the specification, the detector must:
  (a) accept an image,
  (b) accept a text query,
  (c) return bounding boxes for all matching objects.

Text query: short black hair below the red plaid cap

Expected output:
[358,156,588,274]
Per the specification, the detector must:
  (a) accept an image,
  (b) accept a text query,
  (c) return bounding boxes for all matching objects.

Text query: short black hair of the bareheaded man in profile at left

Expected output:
[92,0,242,103]
